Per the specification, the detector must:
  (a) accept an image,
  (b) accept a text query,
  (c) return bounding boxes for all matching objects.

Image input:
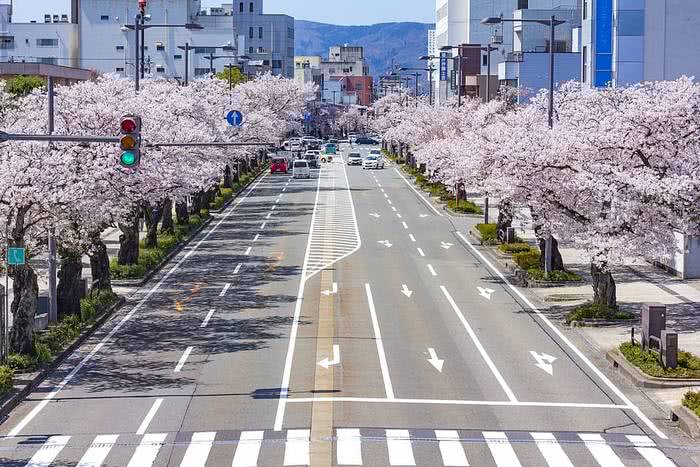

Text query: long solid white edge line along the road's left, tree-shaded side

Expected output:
[7,173,268,438]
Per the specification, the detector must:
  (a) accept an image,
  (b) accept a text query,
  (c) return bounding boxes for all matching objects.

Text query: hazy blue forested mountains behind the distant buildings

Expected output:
[294,20,434,80]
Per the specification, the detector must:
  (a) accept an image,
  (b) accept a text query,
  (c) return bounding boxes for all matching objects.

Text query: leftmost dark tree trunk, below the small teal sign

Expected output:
[10,265,39,355]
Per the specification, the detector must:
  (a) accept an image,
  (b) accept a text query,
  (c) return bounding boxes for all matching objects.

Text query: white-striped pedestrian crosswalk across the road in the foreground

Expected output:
[8,428,675,467]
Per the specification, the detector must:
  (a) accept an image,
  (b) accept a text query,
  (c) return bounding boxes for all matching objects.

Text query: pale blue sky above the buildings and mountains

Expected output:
[13,0,435,24]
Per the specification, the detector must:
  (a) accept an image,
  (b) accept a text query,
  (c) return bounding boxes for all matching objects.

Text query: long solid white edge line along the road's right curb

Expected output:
[457,232,668,439]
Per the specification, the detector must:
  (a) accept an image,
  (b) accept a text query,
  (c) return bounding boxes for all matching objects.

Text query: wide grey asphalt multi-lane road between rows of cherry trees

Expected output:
[0,147,694,467]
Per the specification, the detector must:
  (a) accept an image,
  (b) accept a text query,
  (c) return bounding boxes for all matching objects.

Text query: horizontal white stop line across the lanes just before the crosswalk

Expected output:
[288,397,630,410]
